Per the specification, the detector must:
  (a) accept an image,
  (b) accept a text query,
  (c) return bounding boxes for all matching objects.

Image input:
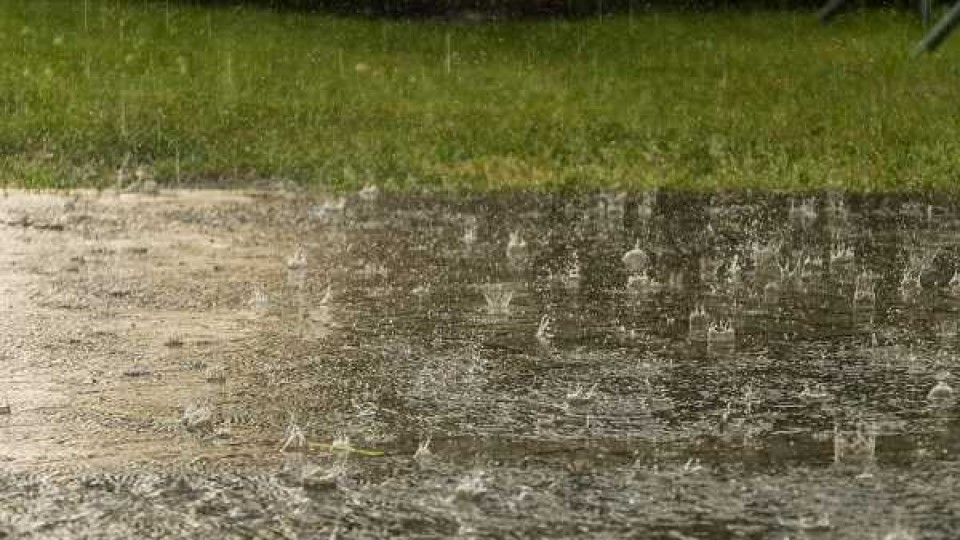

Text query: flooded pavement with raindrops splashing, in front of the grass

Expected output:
[0,190,960,539]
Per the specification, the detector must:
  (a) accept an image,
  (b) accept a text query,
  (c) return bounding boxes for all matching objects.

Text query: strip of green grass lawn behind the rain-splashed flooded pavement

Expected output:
[0,0,960,190]
